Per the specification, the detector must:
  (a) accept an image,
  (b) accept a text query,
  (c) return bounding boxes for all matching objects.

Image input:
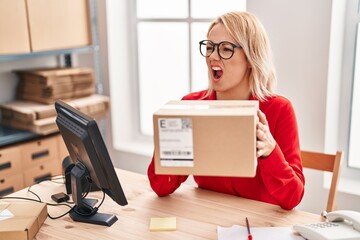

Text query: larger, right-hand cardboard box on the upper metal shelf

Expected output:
[27,0,92,51]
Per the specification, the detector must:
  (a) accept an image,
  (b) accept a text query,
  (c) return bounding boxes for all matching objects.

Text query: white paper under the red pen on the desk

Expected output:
[217,225,305,240]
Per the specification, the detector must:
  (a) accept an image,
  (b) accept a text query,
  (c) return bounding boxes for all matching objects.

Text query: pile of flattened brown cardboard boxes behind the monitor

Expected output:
[0,68,109,135]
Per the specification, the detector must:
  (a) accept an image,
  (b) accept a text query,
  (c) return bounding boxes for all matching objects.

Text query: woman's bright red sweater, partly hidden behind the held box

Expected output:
[148,91,305,209]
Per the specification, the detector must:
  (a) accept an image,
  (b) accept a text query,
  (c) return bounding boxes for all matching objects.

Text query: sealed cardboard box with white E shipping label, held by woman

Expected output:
[153,101,258,177]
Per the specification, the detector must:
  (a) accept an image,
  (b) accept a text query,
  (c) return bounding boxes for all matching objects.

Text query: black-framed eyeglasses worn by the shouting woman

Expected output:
[199,40,241,60]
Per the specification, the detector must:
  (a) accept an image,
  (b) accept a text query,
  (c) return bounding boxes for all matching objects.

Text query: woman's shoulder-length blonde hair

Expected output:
[206,12,276,101]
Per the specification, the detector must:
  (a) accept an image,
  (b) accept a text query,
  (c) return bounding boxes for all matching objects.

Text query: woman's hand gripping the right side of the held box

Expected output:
[256,110,276,158]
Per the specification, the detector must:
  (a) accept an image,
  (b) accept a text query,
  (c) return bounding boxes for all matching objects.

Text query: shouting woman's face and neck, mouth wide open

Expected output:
[206,24,251,100]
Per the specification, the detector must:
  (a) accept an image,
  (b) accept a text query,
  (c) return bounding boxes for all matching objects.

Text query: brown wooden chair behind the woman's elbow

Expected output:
[301,150,343,212]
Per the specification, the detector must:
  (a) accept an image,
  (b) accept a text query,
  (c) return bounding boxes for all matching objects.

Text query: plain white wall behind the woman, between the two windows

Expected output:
[247,0,332,150]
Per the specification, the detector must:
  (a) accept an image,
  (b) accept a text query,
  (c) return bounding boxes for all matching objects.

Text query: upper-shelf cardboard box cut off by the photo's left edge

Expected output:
[0,0,30,54]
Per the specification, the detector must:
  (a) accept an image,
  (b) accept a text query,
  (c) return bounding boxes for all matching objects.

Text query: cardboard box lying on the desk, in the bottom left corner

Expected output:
[0,201,47,240]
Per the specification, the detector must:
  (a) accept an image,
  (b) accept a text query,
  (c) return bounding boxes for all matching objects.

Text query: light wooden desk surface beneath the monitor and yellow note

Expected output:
[5,169,321,240]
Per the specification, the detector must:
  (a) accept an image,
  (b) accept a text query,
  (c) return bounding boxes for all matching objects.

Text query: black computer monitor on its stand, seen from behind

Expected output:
[55,100,127,226]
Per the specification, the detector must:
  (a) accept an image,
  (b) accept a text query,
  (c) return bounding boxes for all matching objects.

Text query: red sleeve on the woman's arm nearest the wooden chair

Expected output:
[259,96,305,209]
